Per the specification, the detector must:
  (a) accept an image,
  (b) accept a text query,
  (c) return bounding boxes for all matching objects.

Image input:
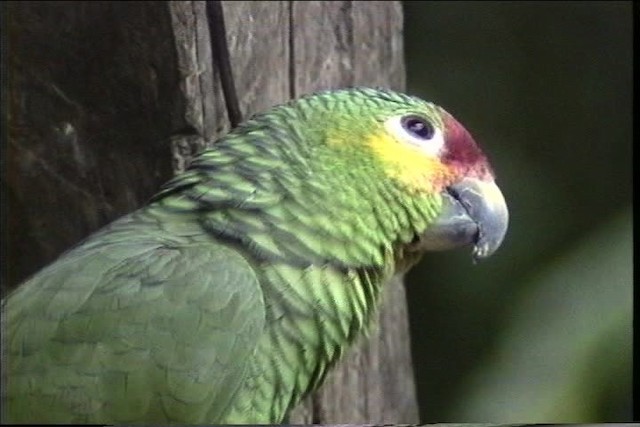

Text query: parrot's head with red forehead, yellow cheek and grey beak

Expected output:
[272,88,509,260]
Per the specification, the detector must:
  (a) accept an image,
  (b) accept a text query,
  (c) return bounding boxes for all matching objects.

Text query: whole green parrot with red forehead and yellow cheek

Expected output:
[2,88,508,424]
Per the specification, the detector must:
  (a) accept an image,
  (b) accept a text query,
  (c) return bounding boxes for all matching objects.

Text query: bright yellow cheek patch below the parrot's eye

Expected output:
[367,132,452,193]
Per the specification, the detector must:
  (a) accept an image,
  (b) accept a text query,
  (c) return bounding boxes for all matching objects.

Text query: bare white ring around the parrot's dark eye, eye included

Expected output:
[384,114,444,157]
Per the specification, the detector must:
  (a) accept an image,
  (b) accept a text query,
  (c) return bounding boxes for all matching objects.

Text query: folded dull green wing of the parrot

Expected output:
[2,226,265,423]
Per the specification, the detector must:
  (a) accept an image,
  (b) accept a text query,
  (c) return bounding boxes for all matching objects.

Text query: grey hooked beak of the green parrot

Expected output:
[418,178,509,261]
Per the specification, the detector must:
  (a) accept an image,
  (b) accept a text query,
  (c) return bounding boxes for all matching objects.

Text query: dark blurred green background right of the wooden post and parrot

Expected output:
[404,1,632,423]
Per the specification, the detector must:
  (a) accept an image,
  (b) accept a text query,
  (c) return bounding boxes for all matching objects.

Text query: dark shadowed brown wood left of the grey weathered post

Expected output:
[2,2,180,288]
